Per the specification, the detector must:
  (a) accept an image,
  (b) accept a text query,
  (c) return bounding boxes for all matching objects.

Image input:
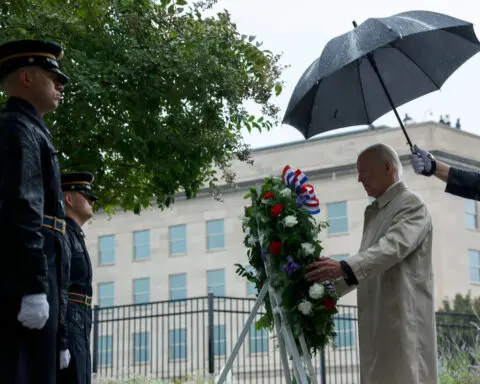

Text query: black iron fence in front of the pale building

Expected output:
[92,295,478,384]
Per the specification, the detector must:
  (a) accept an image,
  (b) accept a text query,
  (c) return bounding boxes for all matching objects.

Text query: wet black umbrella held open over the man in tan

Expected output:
[283,11,480,148]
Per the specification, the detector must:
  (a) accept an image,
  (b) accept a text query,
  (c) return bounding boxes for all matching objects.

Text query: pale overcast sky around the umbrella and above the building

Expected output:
[213,0,480,148]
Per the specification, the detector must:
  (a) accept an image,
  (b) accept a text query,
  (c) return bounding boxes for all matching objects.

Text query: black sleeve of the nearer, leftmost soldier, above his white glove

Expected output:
[0,120,48,295]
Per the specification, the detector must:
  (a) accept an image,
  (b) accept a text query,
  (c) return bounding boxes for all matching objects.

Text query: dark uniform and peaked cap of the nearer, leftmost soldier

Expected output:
[0,40,68,384]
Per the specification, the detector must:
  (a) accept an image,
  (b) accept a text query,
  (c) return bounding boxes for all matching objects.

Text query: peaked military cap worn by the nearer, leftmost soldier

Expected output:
[0,40,68,84]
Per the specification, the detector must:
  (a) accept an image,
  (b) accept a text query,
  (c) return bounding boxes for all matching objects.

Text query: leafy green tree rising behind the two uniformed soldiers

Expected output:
[0,0,282,212]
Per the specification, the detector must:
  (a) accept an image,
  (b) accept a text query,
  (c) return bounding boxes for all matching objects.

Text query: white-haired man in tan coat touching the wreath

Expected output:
[307,144,438,384]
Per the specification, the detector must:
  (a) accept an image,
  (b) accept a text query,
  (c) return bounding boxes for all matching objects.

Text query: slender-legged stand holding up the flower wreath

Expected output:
[216,248,317,384]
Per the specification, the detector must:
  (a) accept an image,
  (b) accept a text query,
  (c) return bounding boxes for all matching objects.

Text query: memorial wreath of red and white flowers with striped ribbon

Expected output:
[236,165,338,354]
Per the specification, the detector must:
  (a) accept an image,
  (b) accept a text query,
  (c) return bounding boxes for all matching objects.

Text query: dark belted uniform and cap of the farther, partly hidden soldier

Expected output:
[58,172,97,384]
